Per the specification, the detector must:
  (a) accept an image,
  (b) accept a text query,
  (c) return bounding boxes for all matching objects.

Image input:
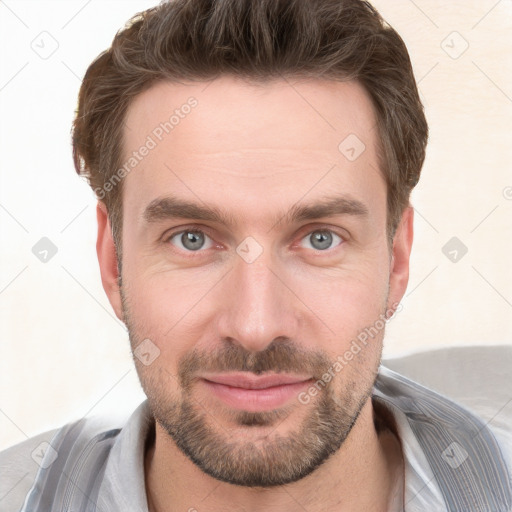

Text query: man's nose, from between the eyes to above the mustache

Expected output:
[218,247,301,352]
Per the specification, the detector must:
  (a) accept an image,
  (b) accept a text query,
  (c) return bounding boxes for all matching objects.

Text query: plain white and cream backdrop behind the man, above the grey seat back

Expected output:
[0,0,512,449]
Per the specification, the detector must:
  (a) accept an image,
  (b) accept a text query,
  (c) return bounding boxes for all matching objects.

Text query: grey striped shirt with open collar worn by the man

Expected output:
[4,366,512,512]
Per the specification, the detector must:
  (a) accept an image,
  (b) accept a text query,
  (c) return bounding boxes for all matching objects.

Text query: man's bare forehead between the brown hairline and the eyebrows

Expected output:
[123,76,385,227]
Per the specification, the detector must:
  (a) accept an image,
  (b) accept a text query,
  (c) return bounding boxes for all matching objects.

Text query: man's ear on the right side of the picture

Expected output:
[388,204,414,311]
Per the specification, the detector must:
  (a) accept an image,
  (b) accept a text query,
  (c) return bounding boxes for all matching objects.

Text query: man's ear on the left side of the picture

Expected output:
[96,201,124,322]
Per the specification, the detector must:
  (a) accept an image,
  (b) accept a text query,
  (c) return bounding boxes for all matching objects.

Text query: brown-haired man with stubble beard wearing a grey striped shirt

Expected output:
[1,0,512,512]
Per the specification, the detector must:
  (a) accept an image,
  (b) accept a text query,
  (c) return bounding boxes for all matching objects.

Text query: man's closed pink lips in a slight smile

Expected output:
[200,372,313,412]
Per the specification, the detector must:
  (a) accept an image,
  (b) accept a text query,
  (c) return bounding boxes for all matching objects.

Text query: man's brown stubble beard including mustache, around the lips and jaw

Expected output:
[123,286,381,488]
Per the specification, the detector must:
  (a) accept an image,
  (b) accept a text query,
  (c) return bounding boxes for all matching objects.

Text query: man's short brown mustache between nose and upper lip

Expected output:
[178,337,331,387]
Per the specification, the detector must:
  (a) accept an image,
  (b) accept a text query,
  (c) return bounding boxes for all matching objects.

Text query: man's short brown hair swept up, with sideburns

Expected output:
[72,0,428,261]
